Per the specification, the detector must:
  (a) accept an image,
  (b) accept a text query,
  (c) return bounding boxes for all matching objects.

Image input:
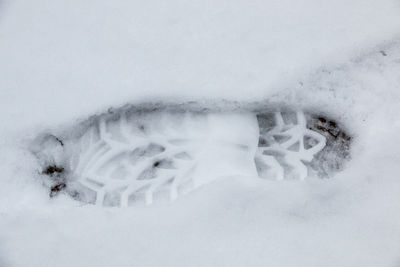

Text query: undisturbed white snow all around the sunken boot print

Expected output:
[0,0,400,267]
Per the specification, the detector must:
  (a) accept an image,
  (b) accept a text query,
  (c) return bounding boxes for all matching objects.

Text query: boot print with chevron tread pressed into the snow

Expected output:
[33,103,348,207]
